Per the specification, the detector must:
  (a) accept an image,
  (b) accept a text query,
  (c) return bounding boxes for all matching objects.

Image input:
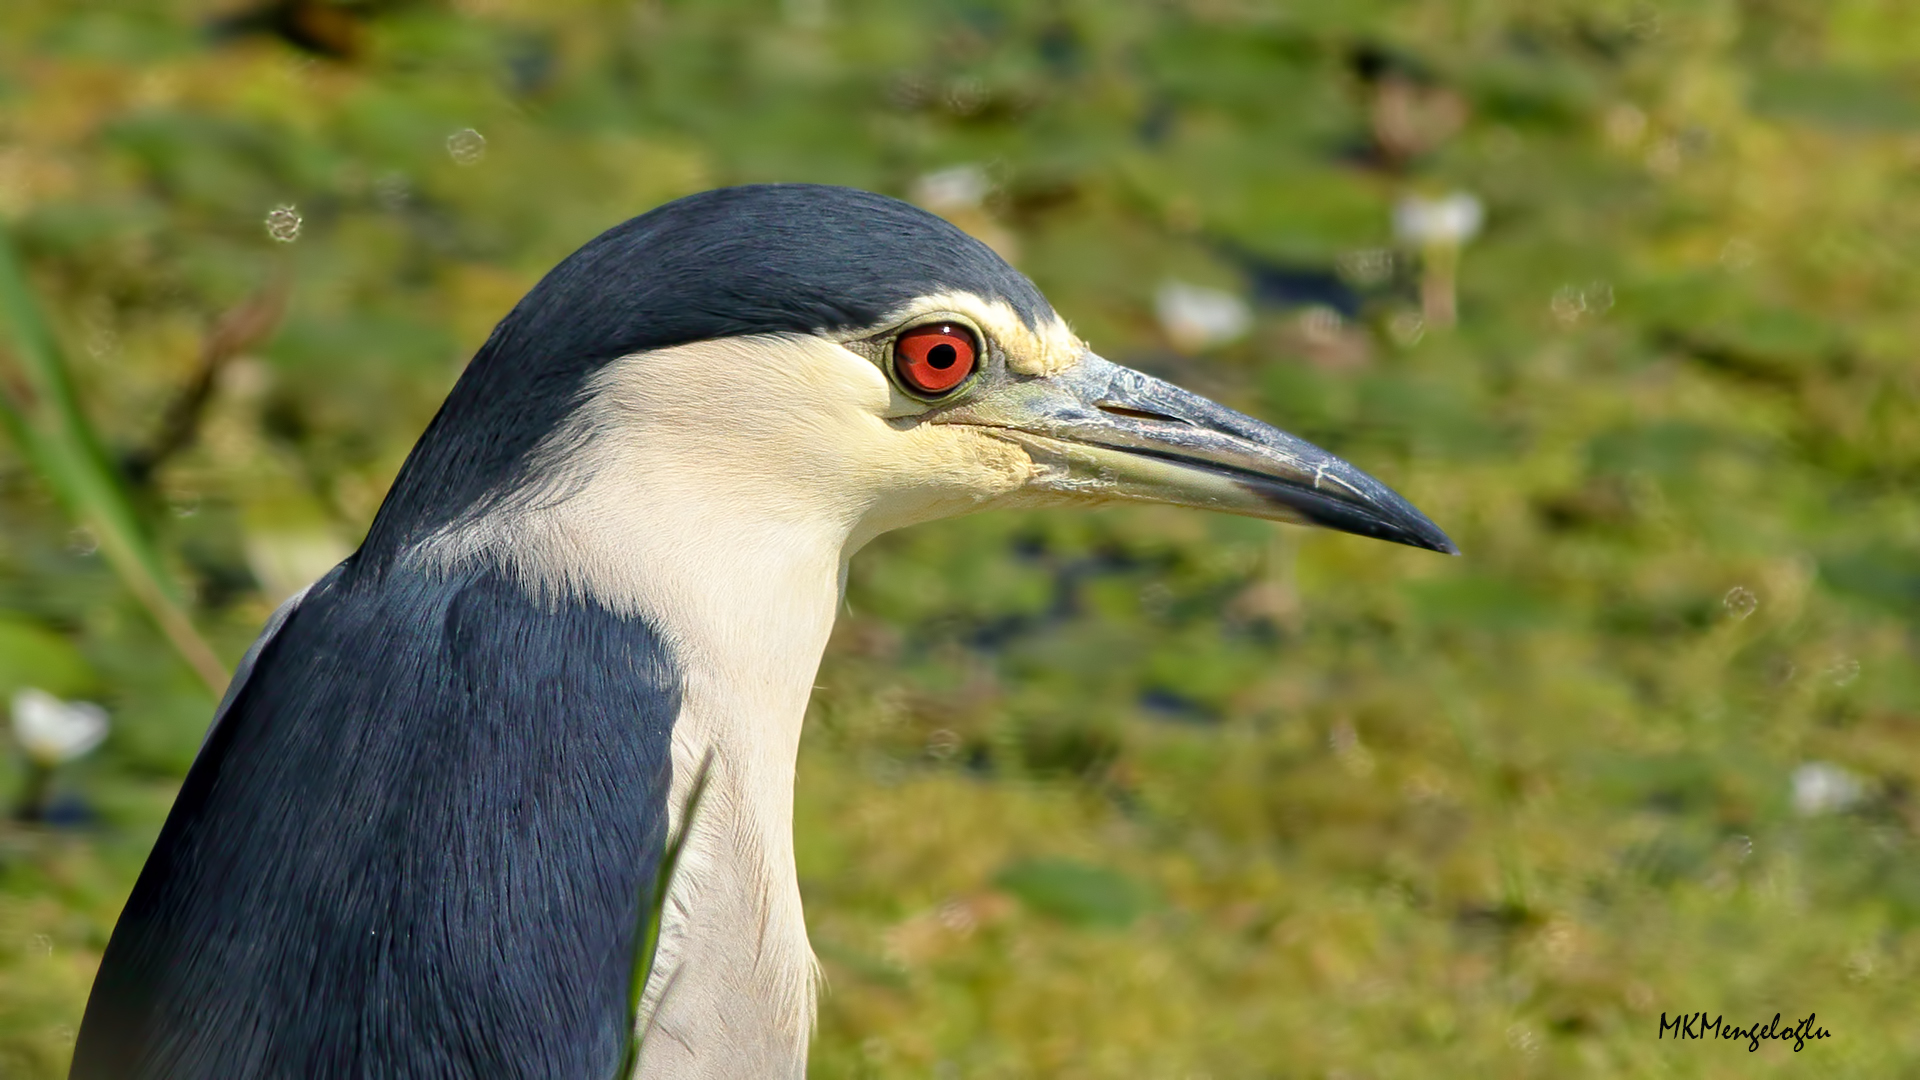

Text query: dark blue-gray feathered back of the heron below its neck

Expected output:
[73,561,680,1080]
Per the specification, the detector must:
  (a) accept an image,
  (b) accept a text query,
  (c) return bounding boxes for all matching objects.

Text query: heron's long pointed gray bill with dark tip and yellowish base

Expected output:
[937,354,1459,555]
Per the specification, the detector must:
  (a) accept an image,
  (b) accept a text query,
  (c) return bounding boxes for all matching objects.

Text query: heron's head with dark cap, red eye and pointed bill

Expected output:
[374,184,1453,576]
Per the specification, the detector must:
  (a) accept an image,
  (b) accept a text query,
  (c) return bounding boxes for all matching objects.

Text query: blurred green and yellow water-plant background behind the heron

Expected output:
[0,0,1920,1080]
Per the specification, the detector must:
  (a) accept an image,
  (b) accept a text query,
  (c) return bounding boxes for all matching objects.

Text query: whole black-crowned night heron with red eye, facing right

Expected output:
[73,184,1453,1080]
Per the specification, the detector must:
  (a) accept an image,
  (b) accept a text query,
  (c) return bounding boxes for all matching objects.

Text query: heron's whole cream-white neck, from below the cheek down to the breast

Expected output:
[439,484,849,1080]
